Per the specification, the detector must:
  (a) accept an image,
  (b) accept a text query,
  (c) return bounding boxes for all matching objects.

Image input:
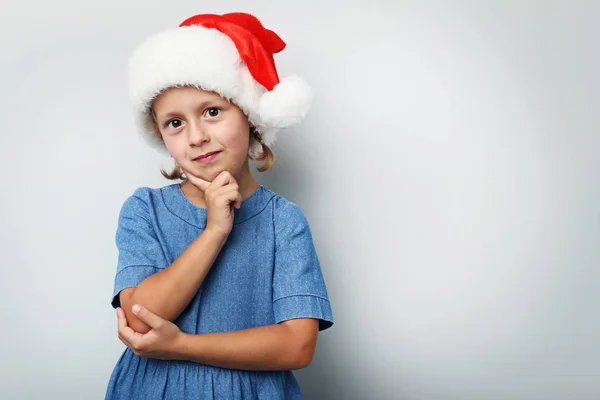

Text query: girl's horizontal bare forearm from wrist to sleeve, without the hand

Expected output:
[175,319,318,371]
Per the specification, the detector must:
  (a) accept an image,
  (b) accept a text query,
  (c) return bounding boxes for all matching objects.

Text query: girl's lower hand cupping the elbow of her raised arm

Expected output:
[117,305,184,360]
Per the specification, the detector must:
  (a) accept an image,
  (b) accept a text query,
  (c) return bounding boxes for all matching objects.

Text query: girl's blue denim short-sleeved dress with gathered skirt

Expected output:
[106,184,333,400]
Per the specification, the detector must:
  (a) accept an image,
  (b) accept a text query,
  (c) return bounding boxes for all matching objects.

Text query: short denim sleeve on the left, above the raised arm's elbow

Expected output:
[111,189,166,308]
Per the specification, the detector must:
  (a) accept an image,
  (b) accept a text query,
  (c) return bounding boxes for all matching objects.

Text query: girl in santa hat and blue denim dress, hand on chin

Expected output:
[106,13,333,400]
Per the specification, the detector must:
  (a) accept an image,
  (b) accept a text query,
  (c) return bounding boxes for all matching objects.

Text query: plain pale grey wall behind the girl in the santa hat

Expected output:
[0,0,600,400]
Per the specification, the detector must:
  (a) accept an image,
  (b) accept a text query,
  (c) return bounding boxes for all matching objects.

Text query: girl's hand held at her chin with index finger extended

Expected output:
[184,171,242,236]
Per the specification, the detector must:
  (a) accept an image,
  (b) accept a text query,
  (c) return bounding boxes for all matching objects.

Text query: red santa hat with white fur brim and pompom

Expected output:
[129,13,312,152]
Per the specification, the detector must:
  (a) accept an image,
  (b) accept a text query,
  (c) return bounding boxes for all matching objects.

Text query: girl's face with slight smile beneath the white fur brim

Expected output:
[153,87,250,182]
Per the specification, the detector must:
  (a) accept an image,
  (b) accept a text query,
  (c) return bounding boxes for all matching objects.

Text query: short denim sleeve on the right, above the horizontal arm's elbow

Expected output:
[273,202,333,330]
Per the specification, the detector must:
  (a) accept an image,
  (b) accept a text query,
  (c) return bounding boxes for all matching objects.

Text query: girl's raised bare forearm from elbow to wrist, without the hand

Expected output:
[119,229,227,333]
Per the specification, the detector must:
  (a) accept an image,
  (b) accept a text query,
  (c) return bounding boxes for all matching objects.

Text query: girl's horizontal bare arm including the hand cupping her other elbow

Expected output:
[117,306,319,371]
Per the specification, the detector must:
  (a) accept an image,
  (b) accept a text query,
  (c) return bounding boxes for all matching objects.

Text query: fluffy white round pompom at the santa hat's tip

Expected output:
[258,76,313,129]
